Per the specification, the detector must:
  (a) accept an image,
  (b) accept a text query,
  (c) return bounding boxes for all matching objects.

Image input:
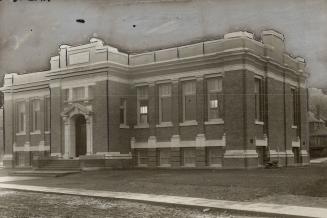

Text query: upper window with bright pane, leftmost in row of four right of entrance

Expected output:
[137,86,149,124]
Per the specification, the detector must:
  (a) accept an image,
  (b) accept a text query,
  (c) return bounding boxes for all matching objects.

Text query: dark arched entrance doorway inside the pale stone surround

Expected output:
[75,115,86,157]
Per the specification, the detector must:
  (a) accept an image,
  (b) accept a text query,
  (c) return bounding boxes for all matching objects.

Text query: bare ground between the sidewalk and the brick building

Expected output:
[5,164,327,207]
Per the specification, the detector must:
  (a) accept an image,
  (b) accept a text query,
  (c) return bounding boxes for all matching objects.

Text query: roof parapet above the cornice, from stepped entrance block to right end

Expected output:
[45,30,305,76]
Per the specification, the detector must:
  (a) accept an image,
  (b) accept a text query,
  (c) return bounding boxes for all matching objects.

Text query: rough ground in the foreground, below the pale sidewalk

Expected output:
[0,189,264,218]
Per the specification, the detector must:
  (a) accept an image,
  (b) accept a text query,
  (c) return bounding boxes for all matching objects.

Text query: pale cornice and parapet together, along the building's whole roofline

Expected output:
[0,30,309,92]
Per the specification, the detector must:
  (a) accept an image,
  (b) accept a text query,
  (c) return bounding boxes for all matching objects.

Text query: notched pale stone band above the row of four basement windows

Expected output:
[131,134,226,149]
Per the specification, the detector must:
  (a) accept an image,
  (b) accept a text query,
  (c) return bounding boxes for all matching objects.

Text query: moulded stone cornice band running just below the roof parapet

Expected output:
[2,49,306,92]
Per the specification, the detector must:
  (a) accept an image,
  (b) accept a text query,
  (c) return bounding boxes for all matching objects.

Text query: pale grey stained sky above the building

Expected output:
[0,0,327,88]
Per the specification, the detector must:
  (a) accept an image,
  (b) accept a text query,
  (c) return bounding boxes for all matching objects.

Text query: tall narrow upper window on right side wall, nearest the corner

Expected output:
[254,78,264,121]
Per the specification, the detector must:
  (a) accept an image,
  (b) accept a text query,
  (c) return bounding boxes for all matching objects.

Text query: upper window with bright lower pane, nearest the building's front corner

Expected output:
[207,78,223,120]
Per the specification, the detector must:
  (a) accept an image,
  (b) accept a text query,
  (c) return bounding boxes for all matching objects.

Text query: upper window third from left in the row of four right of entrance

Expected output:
[183,81,196,121]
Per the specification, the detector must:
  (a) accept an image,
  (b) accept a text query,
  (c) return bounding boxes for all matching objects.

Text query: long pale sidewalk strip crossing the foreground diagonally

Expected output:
[0,183,327,218]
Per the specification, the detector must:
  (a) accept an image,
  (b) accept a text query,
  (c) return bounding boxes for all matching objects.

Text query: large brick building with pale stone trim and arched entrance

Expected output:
[1,30,309,168]
